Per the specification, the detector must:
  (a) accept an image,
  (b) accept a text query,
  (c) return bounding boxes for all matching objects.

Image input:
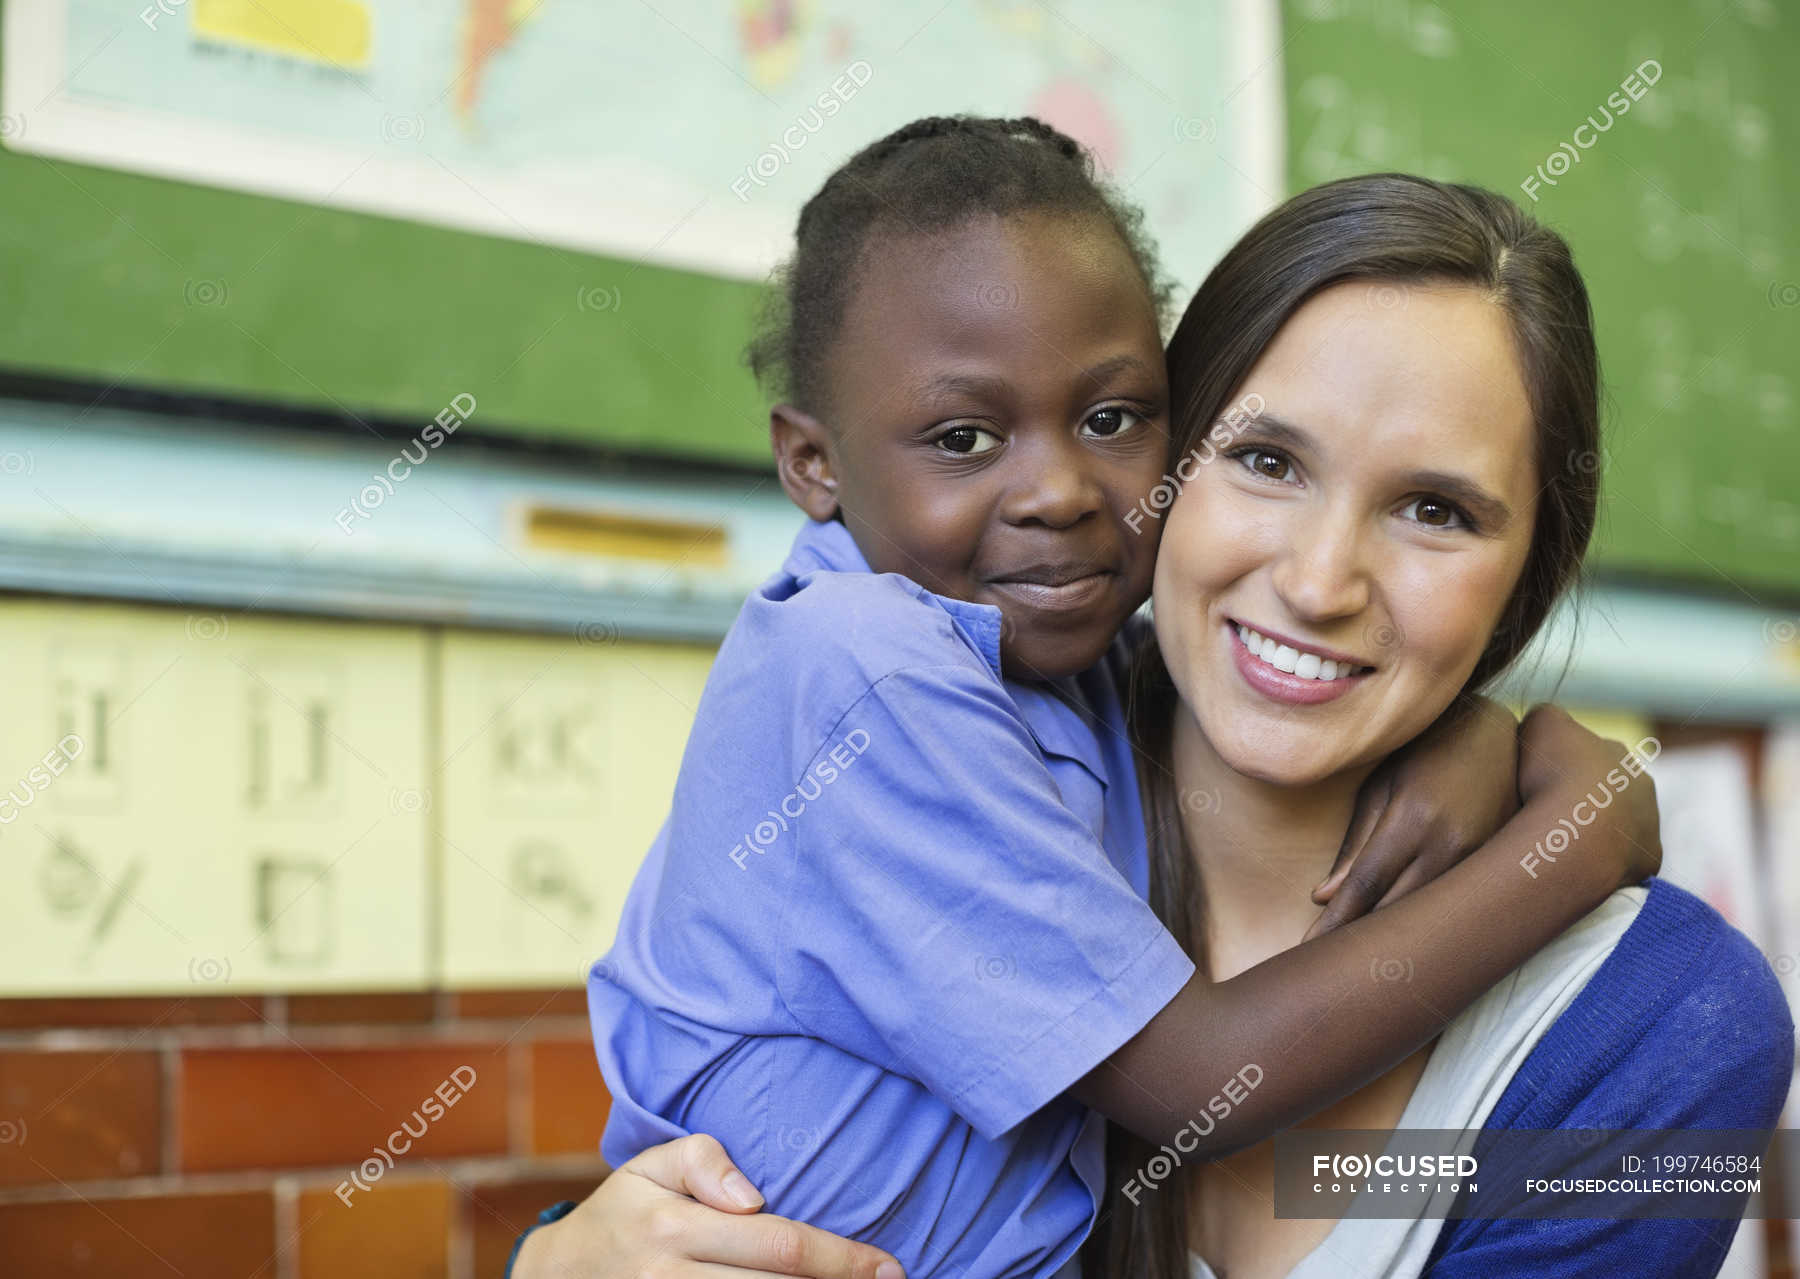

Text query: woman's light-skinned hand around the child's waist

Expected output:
[511,1133,904,1279]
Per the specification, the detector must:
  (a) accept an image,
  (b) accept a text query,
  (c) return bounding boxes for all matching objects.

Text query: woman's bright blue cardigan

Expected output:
[506,880,1795,1279]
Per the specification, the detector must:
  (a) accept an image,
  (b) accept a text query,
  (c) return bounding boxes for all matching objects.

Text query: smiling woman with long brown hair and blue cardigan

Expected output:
[520,174,1793,1279]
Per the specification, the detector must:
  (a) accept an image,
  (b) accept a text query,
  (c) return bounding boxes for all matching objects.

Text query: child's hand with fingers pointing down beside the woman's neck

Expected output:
[1305,698,1519,939]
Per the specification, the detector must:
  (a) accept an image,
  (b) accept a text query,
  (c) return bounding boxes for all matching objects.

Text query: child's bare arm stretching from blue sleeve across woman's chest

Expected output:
[1071,707,1661,1158]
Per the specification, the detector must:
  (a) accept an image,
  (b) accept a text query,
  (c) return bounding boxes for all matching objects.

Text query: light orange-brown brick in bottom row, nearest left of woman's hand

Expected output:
[297,1176,450,1279]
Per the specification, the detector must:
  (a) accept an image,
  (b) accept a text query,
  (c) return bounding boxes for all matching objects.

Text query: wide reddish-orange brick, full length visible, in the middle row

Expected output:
[176,1042,508,1171]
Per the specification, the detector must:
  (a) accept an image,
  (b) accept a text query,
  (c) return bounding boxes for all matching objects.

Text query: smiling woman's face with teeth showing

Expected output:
[1154,281,1537,786]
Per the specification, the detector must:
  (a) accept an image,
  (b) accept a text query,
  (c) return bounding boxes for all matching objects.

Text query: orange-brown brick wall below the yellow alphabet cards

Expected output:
[0,989,608,1279]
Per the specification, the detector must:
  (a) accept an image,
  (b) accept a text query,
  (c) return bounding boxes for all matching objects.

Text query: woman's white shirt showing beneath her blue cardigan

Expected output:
[1192,885,1649,1279]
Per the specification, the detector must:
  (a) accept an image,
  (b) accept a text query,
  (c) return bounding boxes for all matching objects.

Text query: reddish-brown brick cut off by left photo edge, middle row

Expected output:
[0,1052,162,1185]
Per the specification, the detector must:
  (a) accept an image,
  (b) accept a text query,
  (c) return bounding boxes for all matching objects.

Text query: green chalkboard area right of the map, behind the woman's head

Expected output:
[1283,0,1800,595]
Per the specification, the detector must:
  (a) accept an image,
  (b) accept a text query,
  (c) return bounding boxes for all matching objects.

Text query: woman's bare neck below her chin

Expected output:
[1170,707,1372,980]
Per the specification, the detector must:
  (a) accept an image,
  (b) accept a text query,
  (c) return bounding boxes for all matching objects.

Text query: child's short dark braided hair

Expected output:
[745,115,1174,414]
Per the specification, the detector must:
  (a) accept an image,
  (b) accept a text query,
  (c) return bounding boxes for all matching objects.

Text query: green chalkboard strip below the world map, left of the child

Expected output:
[0,11,769,462]
